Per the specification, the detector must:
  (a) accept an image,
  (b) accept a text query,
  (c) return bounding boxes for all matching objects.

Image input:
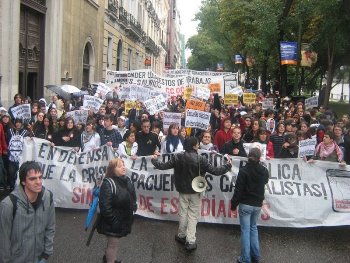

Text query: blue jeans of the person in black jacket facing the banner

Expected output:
[238,204,261,263]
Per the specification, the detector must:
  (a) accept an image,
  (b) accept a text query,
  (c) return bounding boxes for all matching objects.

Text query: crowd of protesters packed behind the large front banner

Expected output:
[0,88,350,190]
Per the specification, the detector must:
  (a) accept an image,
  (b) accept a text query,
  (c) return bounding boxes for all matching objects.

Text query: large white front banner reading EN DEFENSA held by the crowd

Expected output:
[22,138,350,227]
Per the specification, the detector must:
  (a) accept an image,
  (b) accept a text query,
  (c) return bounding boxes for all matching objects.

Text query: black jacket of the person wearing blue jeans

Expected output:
[231,161,269,210]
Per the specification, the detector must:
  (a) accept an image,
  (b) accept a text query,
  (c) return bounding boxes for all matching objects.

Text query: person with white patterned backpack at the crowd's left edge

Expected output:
[7,119,29,190]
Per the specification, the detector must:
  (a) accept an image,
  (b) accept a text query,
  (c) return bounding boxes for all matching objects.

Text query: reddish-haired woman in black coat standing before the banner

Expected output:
[97,158,137,263]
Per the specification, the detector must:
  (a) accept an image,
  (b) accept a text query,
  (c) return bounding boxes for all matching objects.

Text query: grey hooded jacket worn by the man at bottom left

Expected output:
[0,186,55,263]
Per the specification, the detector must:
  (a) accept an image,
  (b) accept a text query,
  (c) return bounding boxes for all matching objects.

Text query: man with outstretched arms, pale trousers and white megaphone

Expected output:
[152,137,232,251]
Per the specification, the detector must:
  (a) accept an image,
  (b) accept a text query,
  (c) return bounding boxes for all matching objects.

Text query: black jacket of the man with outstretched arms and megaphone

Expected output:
[152,150,232,194]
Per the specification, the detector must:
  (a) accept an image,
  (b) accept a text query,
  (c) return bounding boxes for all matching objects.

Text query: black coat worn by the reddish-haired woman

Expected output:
[97,176,137,237]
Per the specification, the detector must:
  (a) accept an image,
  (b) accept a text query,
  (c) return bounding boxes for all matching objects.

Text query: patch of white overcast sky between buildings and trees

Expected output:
[177,0,201,57]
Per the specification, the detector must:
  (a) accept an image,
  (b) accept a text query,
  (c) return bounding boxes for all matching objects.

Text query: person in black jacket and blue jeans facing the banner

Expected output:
[231,148,269,263]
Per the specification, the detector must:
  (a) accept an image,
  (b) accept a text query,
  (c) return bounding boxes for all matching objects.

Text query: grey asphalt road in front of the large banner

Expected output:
[50,209,350,263]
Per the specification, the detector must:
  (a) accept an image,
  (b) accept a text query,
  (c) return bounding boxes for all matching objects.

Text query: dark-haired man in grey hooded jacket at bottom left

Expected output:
[0,161,55,263]
